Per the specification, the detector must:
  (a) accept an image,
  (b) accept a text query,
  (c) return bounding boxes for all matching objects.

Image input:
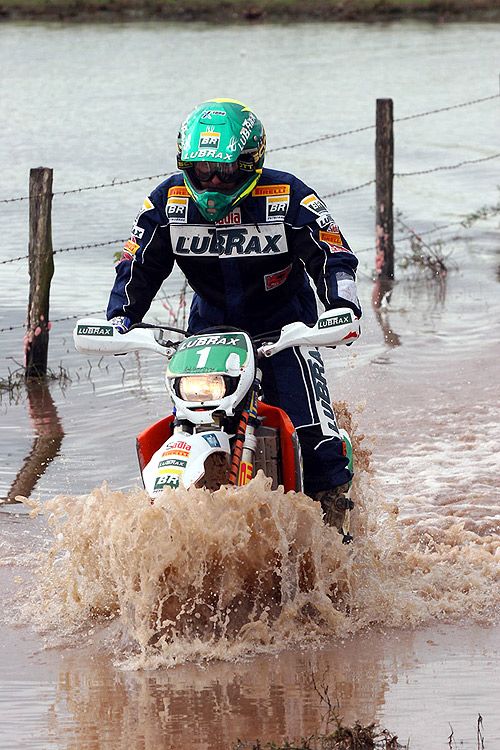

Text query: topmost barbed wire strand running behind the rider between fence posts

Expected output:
[0,93,500,203]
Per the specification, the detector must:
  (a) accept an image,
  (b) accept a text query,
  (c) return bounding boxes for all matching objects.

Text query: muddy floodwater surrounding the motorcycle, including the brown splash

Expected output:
[0,16,500,748]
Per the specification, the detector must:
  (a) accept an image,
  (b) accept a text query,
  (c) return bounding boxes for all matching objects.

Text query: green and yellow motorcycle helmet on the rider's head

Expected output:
[177,99,266,222]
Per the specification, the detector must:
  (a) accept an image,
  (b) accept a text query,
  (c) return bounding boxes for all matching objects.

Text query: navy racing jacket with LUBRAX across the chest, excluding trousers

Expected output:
[107,169,361,335]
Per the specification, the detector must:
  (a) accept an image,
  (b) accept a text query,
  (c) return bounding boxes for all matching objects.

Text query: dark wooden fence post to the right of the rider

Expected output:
[375,99,394,279]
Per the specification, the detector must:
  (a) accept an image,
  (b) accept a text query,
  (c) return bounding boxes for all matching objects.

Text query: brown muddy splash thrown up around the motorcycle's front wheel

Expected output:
[13,414,500,668]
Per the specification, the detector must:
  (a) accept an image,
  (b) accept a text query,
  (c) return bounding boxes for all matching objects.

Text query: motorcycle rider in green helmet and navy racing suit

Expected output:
[107,99,361,530]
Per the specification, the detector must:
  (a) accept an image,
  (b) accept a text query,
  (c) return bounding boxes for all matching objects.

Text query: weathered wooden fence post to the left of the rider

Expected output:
[24,167,54,378]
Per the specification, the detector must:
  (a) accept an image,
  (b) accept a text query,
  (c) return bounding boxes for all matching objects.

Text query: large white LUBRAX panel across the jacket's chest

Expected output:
[170,222,288,258]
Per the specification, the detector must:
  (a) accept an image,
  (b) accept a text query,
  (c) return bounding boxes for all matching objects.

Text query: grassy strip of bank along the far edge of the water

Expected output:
[0,0,500,23]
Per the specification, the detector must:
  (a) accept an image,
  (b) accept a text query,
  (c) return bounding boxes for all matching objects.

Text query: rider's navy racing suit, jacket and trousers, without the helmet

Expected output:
[107,169,361,495]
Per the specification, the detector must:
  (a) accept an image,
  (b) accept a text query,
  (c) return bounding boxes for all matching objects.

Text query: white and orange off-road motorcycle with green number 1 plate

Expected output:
[73,308,359,542]
